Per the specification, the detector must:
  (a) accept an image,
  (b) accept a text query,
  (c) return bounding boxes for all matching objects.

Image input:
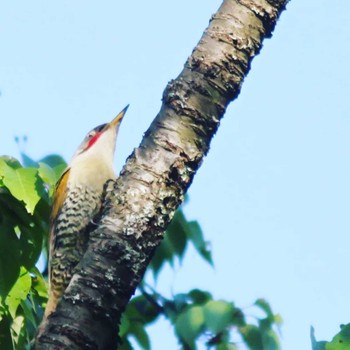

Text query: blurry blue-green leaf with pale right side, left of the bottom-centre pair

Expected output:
[175,306,205,349]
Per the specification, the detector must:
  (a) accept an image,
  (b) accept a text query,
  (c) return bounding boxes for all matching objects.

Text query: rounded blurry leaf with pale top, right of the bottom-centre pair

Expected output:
[203,300,235,334]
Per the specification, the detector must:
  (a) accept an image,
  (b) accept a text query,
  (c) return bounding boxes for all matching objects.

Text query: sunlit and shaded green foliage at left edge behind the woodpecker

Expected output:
[0,156,65,350]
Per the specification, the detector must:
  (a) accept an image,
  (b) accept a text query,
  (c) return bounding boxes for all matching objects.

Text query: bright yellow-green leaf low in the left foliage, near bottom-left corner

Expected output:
[5,267,32,319]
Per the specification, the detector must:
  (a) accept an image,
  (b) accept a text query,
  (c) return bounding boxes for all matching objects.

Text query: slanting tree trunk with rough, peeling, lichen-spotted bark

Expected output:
[35,0,288,350]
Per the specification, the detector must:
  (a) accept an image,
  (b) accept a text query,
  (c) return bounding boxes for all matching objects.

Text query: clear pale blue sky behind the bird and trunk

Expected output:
[0,0,350,350]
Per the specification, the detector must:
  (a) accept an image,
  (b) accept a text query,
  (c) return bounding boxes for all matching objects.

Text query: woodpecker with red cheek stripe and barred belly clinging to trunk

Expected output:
[44,106,128,318]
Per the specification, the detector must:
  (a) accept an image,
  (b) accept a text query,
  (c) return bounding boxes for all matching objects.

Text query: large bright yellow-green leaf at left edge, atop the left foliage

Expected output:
[0,163,40,214]
